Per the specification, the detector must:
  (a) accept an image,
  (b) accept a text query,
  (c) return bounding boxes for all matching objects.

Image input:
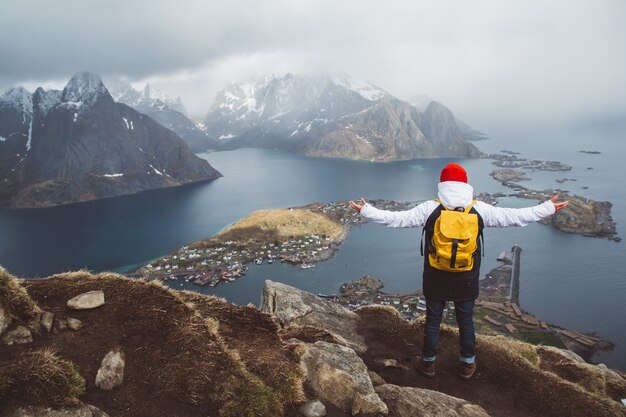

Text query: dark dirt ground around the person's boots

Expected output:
[357,310,626,417]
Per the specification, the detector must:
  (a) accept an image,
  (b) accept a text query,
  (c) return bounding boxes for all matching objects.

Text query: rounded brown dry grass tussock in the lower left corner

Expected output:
[0,349,85,406]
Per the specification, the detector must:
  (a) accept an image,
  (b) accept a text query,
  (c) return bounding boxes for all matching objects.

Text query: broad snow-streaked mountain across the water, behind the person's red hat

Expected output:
[204,74,480,161]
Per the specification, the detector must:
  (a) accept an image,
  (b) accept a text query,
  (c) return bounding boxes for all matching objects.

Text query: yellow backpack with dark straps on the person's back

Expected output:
[422,200,482,272]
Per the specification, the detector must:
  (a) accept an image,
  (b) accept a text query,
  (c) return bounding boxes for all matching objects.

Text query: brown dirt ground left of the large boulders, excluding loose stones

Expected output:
[0,274,301,417]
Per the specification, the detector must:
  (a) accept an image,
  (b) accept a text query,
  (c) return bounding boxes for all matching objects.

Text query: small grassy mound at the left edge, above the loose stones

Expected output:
[0,266,41,327]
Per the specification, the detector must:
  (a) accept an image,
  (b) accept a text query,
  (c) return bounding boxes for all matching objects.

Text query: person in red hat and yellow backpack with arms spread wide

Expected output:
[350,164,567,379]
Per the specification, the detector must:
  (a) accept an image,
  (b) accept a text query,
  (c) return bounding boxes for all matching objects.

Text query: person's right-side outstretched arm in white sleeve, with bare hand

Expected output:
[476,195,568,227]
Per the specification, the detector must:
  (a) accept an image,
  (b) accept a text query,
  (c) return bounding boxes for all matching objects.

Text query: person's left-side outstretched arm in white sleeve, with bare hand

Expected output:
[350,198,437,227]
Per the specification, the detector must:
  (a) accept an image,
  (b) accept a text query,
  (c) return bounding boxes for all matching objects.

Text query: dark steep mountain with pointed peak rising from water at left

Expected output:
[0,73,221,208]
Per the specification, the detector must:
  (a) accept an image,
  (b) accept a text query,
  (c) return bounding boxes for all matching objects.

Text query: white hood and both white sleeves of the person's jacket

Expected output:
[361,181,556,227]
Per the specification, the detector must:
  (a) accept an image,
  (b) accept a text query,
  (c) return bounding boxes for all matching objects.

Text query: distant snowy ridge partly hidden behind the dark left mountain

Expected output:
[110,81,217,152]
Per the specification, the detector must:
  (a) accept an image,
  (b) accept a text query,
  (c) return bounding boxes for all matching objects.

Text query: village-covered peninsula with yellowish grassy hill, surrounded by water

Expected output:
[132,200,410,286]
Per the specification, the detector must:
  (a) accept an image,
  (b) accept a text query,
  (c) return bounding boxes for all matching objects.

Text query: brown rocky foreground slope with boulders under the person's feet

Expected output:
[0,267,626,417]
